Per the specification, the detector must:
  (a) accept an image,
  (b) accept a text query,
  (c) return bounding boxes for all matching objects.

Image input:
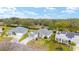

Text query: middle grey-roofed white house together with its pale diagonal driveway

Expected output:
[20,29,52,45]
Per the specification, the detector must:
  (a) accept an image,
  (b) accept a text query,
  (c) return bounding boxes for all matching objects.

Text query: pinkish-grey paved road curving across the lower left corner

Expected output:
[0,41,34,51]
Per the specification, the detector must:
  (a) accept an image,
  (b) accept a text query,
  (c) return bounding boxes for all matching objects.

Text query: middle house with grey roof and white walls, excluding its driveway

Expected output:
[29,29,52,39]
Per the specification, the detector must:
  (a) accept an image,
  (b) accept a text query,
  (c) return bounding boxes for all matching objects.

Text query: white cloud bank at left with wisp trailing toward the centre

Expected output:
[0,7,38,18]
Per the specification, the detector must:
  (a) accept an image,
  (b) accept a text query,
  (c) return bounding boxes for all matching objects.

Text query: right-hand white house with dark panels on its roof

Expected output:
[55,31,79,46]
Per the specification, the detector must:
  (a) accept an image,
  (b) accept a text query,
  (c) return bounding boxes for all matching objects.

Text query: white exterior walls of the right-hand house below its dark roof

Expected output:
[55,34,79,46]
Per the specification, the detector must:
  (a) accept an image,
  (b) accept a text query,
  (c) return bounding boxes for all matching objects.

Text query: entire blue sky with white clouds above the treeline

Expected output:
[0,7,79,19]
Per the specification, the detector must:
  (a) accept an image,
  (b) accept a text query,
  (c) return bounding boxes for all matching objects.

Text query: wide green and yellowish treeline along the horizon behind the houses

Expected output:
[0,17,79,31]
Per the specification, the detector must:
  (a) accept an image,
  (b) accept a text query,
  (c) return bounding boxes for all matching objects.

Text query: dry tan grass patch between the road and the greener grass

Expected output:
[27,39,48,50]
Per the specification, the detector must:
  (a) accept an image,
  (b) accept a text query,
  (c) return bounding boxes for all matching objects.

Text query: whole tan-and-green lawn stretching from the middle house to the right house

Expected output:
[27,36,72,51]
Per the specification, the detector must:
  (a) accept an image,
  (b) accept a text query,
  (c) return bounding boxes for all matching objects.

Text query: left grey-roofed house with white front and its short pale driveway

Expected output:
[8,27,28,42]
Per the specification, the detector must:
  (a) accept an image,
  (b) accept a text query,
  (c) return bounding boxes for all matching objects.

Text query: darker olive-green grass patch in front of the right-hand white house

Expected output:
[47,41,72,51]
